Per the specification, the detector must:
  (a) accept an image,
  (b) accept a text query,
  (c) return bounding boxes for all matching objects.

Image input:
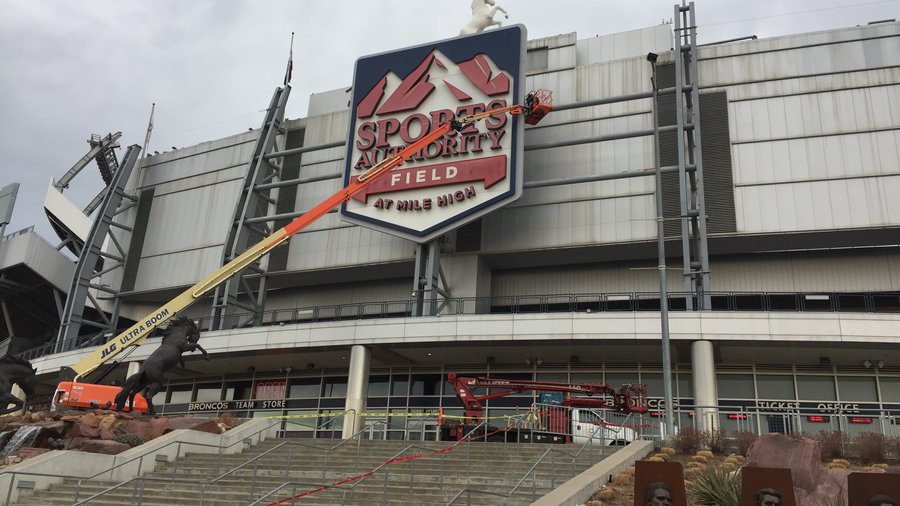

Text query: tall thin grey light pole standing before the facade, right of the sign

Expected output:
[647,53,680,439]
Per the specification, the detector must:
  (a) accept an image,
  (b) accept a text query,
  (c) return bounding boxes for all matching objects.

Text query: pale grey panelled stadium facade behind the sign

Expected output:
[0,7,900,438]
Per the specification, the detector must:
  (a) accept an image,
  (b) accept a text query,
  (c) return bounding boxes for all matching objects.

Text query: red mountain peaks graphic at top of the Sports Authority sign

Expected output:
[356,51,510,118]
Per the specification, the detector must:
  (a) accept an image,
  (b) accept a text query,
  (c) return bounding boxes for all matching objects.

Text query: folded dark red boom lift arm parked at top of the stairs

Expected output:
[447,372,647,423]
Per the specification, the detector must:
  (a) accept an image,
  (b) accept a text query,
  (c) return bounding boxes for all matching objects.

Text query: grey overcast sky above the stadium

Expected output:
[0,0,900,244]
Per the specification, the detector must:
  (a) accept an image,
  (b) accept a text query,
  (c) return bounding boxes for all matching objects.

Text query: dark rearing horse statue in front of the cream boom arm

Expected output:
[115,316,209,415]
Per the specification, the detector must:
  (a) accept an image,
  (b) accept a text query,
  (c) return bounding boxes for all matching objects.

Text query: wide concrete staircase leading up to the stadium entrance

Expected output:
[15,439,617,506]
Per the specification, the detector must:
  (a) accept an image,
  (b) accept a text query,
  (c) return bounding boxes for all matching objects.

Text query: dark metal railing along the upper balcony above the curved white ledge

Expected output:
[24,292,900,360]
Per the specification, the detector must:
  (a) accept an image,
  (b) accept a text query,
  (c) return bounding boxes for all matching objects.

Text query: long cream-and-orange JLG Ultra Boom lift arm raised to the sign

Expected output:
[72,90,552,381]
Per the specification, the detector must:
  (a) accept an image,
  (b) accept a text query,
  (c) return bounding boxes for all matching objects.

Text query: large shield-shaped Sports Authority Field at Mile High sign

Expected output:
[341,25,526,242]
